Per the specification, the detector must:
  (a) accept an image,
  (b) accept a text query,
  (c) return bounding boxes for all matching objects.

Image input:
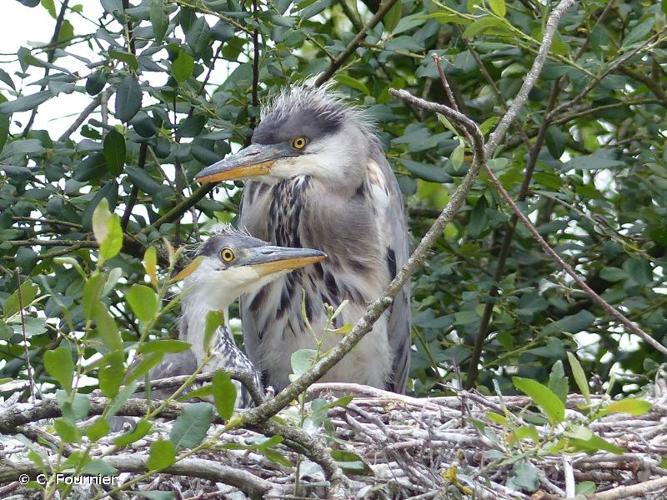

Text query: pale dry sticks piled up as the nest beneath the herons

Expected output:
[0,392,667,499]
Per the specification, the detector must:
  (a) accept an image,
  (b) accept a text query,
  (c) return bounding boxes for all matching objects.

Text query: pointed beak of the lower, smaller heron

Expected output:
[241,246,327,276]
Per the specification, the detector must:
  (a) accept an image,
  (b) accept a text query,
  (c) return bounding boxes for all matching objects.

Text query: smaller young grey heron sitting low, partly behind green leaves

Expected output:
[145,227,326,406]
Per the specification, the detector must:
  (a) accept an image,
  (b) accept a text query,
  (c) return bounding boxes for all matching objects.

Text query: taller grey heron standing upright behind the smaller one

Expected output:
[196,86,411,392]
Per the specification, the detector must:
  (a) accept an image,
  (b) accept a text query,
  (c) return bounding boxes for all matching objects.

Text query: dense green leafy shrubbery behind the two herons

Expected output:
[0,0,667,395]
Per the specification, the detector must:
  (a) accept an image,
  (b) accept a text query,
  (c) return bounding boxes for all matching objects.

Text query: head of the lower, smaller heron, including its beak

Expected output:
[184,227,326,309]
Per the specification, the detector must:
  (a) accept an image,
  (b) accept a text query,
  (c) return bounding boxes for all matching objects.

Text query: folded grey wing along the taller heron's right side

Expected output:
[373,148,412,394]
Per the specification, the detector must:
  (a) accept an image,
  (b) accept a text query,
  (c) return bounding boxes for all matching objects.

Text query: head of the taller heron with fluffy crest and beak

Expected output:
[196,86,377,187]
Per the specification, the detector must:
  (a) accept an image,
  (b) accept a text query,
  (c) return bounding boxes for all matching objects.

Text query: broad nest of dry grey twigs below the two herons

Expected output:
[0,384,667,500]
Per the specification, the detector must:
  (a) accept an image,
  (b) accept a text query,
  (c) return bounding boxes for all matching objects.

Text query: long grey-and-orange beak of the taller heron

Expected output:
[195,144,295,183]
